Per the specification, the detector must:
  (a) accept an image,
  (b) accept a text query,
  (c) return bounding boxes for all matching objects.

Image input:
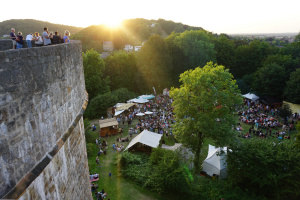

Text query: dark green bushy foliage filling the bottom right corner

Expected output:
[227,139,300,199]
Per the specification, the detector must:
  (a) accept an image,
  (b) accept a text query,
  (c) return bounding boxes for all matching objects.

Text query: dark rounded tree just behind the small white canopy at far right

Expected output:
[252,63,285,98]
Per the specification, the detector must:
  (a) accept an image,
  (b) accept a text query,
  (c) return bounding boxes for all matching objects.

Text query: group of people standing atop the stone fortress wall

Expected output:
[10,27,70,49]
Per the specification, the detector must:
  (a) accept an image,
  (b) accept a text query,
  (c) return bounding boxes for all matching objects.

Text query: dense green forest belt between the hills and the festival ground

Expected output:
[81,19,300,120]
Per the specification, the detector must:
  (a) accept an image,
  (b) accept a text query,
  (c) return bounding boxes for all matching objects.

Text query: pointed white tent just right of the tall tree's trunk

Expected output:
[203,145,227,179]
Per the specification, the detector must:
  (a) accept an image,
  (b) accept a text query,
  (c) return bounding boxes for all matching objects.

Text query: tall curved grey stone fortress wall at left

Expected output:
[0,40,92,200]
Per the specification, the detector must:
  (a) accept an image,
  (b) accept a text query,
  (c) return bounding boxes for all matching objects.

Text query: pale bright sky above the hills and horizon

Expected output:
[0,0,300,34]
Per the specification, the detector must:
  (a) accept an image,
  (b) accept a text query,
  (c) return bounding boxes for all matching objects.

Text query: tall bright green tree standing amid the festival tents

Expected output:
[170,62,242,171]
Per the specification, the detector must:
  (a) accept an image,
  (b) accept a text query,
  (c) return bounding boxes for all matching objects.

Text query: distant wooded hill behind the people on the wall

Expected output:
[0,19,83,37]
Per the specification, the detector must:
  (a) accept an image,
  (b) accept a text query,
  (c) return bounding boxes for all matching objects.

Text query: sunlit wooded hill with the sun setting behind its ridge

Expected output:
[72,18,204,53]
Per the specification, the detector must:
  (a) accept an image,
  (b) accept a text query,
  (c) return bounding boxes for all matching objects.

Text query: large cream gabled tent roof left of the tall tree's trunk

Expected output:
[125,130,162,151]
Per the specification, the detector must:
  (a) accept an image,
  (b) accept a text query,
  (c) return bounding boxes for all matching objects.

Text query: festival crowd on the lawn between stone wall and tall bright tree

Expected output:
[90,95,175,199]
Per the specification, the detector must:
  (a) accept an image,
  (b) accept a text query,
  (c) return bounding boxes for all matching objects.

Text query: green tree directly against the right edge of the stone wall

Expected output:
[82,49,110,100]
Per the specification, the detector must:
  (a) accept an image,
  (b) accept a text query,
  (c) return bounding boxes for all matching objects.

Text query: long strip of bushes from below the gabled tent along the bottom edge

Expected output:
[120,151,265,200]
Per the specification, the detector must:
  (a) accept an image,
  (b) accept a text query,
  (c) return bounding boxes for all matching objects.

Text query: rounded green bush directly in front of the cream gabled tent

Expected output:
[120,148,191,193]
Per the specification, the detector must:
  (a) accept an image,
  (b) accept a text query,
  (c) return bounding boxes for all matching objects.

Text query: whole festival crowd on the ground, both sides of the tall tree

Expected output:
[92,95,299,199]
